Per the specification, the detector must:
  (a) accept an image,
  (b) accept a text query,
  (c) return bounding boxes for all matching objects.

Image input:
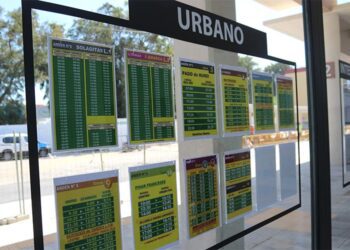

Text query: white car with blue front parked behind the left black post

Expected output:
[0,133,50,161]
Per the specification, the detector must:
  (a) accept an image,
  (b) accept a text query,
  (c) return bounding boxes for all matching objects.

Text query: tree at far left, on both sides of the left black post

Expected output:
[0,8,64,122]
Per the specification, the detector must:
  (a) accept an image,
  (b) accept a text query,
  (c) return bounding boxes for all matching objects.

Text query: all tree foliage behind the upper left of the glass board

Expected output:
[0,3,172,120]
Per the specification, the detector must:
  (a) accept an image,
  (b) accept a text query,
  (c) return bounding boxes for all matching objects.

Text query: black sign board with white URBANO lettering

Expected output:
[129,0,268,57]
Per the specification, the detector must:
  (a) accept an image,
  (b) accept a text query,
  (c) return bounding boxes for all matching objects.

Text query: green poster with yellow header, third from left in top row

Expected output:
[180,59,218,139]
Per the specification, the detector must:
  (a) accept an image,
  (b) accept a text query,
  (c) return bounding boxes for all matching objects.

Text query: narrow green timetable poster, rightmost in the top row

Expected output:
[276,76,295,130]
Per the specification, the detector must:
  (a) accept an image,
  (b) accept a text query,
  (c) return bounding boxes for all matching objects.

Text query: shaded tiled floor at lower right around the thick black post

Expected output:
[245,164,350,250]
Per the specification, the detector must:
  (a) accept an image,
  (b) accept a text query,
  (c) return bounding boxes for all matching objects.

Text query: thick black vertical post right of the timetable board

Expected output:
[303,0,332,250]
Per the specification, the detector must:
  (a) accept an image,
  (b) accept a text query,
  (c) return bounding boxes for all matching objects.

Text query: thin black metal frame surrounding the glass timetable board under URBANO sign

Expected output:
[22,0,301,249]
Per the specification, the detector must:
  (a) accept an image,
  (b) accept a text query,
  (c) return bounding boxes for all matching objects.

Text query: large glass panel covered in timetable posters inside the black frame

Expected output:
[34,4,300,249]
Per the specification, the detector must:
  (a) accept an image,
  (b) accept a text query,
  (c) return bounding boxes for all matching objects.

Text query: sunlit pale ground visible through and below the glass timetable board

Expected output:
[0,142,350,250]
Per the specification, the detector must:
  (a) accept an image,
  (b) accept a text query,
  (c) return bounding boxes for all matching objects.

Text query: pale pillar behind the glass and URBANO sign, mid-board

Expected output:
[174,0,244,249]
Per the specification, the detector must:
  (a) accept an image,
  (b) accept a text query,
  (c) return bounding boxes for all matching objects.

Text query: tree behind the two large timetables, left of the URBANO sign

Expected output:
[67,3,172,118]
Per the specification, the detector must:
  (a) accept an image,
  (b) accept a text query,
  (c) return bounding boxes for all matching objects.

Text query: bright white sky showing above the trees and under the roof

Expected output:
[0,0,350,104]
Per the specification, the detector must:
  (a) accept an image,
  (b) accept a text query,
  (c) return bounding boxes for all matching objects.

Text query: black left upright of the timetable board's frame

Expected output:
[22,0,44,246]
